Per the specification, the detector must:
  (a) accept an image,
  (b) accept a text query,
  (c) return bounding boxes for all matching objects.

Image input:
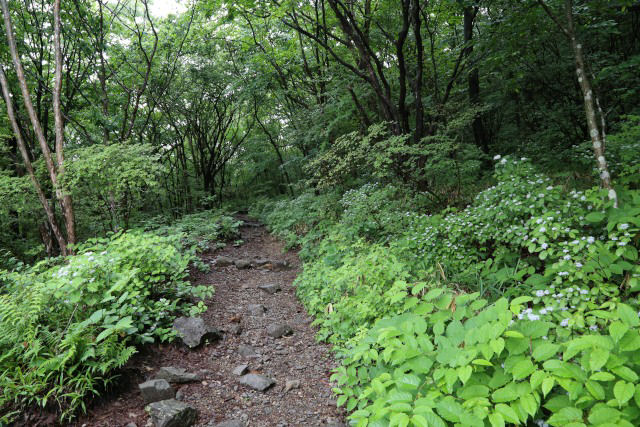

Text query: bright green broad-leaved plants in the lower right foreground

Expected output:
[333,286,640,426]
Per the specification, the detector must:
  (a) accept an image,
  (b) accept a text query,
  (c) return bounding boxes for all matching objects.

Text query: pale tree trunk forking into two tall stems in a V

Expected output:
[0,0,75,253]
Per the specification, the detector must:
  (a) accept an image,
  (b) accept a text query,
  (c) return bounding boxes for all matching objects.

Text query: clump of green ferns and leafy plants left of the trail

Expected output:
[0,231,212,422]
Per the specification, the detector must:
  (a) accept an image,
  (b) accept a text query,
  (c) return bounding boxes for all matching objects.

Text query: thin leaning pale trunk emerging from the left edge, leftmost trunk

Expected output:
[0,67,67,255]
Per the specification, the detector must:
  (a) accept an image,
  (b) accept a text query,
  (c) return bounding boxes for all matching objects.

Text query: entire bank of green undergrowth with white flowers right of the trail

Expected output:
[260,149,640,427]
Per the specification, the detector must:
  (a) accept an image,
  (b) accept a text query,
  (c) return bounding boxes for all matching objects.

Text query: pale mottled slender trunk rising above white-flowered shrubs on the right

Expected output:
[538,0,618,208]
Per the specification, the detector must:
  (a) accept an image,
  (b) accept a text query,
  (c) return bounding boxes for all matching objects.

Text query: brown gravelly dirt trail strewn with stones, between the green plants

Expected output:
[75,218,344,427]
